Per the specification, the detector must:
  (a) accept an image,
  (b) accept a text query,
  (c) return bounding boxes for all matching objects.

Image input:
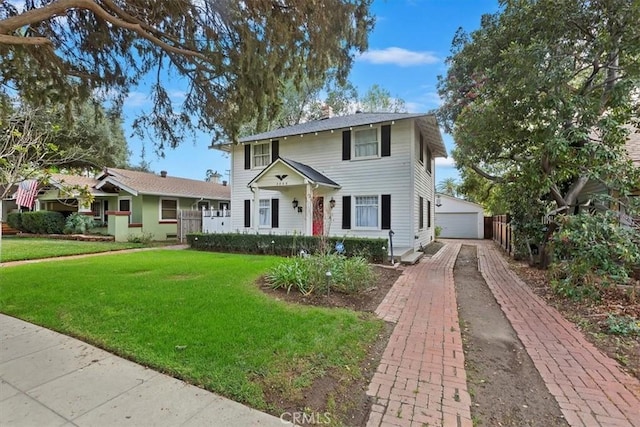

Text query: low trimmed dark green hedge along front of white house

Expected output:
[187,233,388,263]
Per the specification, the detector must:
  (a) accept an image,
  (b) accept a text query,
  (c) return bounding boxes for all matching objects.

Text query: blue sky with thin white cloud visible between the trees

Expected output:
[124,0,498,186]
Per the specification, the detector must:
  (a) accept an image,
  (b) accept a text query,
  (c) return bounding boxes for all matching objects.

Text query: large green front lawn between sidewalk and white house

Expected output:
[0,250,382,413]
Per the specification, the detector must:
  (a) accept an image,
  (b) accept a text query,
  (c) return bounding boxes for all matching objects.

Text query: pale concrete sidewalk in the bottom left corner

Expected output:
[0,314,290,427]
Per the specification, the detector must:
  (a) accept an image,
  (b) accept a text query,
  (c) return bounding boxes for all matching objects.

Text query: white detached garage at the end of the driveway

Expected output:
[435,194,484,239]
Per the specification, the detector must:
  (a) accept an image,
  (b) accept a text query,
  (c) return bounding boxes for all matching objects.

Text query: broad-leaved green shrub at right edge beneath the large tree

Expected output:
[549,212,640,299]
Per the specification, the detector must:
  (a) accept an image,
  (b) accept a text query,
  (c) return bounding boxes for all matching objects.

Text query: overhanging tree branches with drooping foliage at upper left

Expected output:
[0,0,373,149]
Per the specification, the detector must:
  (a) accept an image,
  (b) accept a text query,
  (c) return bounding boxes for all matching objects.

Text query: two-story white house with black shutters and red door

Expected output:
[211,113,446,255]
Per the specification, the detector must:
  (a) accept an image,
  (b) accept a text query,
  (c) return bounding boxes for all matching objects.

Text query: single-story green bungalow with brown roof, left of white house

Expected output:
[37,168,231,241]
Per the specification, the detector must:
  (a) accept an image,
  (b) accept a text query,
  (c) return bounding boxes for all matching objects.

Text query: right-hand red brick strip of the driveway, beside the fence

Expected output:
[474,242,640,427]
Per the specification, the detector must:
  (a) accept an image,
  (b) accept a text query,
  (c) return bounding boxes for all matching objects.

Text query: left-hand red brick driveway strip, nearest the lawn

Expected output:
[367,244,472,427]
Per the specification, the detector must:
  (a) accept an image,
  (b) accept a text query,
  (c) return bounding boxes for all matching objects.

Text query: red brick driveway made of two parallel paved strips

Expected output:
[367,240,640,427]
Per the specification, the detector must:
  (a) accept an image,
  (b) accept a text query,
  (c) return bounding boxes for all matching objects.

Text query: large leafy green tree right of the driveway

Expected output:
[439,0,640,258]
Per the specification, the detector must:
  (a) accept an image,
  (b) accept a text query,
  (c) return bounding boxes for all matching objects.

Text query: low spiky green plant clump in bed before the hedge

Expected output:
[267,253,375,295]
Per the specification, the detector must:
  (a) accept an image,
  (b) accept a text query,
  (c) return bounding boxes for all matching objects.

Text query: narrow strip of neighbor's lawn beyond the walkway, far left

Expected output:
[0,237,144,262]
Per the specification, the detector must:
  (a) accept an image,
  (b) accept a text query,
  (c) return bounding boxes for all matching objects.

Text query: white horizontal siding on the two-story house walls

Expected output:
[231,120,434,248]
